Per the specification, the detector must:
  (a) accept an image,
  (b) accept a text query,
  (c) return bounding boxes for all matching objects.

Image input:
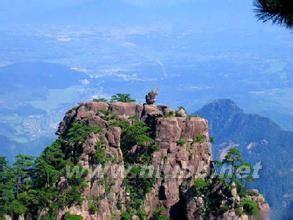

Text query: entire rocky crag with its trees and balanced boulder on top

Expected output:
[0,95,269,220]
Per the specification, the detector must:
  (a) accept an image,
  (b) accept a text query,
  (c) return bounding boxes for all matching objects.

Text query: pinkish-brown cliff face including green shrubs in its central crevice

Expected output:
[50,102,265,219]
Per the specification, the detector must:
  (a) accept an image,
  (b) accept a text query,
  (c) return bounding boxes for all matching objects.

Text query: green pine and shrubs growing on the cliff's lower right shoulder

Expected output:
[193,148,258,218]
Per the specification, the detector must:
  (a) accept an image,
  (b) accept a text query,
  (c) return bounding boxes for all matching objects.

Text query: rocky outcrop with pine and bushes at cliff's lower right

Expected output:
[193,147,259,219]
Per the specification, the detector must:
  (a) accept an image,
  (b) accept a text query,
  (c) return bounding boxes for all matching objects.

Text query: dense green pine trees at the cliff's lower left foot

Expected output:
[0,139,85,219]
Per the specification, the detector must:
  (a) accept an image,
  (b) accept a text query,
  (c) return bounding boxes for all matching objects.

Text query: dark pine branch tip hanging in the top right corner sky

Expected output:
[255,0,293,28]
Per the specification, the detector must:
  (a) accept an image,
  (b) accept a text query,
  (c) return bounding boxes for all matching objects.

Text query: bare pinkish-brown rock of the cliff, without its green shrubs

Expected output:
[53,99,268,220]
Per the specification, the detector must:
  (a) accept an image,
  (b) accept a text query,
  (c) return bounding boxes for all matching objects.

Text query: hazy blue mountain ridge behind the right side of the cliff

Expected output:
[196,99,293,219]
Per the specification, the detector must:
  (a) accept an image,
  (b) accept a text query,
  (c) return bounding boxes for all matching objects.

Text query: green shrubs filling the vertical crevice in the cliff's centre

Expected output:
[113,119,157,219]
